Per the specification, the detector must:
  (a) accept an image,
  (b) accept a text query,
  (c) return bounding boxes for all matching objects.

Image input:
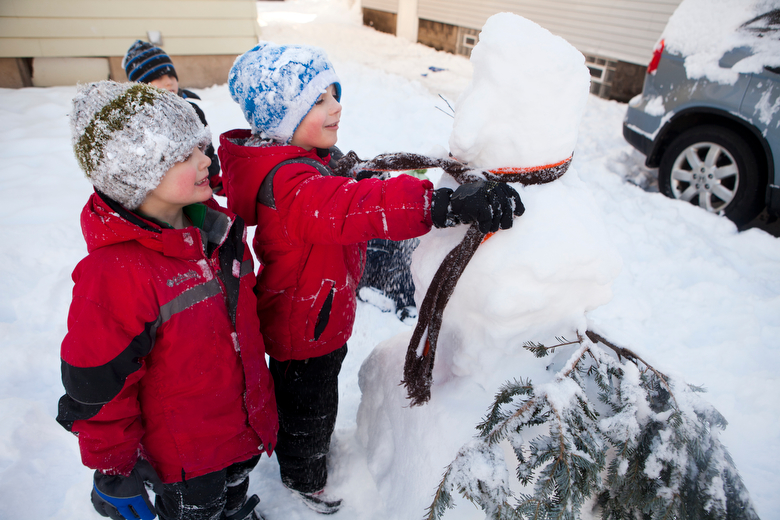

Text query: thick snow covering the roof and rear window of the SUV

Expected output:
[661,0,780,84]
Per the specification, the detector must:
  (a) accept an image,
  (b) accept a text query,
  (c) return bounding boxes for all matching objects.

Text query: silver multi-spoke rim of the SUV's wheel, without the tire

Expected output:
[671,142,739,213]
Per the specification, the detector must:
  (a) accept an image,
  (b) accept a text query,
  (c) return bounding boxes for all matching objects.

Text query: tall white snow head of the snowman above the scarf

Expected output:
[450,13,590,168]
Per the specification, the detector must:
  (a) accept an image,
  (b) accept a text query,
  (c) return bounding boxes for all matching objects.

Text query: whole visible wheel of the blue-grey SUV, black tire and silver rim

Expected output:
[658,126,766,226]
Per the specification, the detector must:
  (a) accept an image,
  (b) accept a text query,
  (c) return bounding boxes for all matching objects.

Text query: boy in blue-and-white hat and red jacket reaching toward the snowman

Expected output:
[219,42,522,514]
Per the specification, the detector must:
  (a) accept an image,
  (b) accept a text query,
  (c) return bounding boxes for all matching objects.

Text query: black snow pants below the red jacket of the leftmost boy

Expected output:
[154,455,260,520]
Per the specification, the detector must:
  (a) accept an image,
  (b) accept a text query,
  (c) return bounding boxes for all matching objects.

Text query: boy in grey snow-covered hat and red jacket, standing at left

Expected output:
[57,81,278,520]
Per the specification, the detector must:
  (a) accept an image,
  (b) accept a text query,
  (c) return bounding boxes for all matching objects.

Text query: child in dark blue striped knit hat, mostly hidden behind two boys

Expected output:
[122,40,222,195]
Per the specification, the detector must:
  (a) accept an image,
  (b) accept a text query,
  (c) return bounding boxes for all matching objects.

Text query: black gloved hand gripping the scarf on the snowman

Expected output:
[442,180,525,233]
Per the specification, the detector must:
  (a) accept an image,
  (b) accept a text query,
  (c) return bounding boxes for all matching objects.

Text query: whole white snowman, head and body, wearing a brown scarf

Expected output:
[358,13,621,518]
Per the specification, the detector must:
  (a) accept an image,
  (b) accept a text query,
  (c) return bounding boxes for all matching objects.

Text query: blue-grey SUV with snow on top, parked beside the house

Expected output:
[623,9,780,226]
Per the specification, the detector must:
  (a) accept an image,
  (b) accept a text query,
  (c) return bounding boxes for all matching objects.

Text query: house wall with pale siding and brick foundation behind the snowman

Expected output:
[362,0,681,101]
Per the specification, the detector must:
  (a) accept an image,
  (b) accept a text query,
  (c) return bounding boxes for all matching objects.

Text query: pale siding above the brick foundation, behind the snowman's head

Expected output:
[418,0,681,64]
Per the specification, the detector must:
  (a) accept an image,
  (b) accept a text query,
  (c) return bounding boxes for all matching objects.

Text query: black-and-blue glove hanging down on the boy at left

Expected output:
[92,459,162,520]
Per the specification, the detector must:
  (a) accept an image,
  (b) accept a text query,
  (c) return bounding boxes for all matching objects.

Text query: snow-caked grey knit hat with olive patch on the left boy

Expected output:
[70,81,211,210]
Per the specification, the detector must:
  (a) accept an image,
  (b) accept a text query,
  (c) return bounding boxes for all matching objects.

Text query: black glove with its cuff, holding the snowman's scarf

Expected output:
[431,180,525,233]
